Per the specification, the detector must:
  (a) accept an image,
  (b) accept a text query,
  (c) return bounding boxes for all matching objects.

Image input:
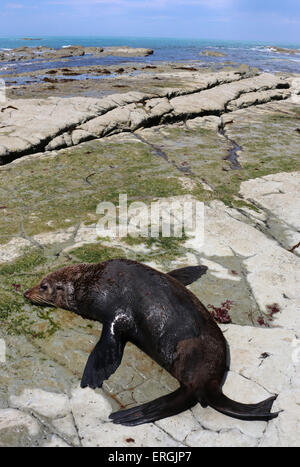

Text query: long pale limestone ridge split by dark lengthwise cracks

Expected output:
[0,72,290,163]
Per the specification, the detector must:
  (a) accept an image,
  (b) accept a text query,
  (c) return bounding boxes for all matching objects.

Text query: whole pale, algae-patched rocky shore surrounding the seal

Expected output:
[0,60,300,447]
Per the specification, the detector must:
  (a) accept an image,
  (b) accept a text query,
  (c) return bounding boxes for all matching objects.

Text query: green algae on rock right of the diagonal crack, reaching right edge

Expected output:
[141,107,300,210]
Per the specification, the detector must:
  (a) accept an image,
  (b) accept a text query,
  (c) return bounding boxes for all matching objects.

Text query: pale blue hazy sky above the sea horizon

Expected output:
[0,0,300,44]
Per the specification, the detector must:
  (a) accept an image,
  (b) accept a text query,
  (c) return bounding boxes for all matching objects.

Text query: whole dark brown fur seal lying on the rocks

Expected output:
[25,259,278,426]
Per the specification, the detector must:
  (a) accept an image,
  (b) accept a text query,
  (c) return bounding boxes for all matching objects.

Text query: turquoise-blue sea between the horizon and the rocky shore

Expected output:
[0,36,300,75]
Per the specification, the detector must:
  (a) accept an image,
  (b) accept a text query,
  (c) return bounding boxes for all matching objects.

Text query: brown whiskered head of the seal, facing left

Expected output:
[24,266,77,311]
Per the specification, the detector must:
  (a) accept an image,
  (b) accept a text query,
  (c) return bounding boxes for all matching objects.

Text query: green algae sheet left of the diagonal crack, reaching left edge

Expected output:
[0,138,184,243]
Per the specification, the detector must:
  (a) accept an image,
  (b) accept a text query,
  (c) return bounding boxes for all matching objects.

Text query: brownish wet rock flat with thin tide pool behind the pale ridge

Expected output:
[1,62,258,99]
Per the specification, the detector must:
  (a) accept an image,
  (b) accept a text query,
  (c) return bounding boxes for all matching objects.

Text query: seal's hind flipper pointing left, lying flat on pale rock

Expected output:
[109,387,197,426]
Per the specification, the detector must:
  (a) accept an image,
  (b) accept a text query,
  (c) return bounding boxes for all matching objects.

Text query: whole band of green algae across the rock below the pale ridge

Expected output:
[0,106,300,243]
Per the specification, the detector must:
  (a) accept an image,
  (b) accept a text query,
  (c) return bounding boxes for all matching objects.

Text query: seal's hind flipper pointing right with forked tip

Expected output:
[206,385,280,421]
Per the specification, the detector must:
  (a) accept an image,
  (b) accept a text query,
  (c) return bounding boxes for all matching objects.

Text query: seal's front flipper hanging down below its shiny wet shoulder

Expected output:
[81,324,125,389]
